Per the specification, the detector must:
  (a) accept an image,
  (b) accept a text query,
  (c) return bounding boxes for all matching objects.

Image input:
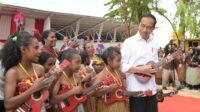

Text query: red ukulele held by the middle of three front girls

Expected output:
[58,77,113,112]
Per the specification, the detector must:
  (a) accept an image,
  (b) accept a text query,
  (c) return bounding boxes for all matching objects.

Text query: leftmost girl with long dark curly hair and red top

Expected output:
[1,31,57,112]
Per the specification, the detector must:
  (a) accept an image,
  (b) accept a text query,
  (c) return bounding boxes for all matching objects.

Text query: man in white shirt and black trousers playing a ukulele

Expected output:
[121,14,158,112]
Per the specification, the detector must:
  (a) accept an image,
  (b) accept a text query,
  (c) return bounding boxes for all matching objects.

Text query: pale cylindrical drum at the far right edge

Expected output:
[186,67,200,86]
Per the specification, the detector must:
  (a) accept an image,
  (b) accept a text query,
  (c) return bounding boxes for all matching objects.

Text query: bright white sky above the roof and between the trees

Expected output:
[0,0,176,47]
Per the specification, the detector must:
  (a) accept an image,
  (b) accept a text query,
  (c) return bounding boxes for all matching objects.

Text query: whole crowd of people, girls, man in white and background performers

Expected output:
[0,14,199,112]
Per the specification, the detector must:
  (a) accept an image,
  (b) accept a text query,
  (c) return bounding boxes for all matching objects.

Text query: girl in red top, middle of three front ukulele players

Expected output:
[50,48,84,112]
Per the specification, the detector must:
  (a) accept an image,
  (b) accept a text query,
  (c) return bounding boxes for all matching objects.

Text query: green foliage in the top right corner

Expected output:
[173,0,200,39]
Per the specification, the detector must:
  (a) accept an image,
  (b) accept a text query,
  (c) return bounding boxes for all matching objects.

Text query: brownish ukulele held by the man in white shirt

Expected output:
[135,50,181,83]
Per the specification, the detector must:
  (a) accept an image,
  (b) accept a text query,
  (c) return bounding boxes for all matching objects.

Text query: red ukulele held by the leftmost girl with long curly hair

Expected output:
[15,60,69,112]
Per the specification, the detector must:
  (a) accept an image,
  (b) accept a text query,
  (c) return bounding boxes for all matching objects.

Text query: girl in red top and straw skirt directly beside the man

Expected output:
[94,47,128,112]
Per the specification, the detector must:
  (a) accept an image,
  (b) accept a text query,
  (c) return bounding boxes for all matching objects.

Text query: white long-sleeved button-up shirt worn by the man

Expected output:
[121,32,158,94]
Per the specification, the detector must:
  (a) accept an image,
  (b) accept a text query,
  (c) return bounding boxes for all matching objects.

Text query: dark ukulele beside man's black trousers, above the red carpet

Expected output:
[156,90,178,102]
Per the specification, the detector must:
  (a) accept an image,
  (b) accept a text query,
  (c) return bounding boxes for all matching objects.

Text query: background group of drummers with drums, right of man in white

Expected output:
[158,40,200,90]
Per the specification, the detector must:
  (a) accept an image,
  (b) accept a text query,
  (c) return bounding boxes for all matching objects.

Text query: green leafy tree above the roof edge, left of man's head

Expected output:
[105,0,154,37]
